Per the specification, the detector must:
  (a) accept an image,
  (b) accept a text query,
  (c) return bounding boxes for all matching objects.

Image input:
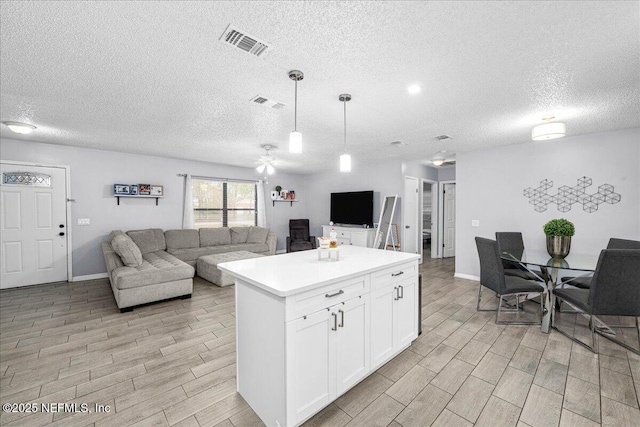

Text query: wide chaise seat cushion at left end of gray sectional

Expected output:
[111,251,195,289]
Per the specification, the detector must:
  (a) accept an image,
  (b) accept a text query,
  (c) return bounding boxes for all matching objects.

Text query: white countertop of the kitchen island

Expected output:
[218,246,420,297]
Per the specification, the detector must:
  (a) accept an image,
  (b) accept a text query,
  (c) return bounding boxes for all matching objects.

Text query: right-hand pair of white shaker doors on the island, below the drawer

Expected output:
[371,276,420,369]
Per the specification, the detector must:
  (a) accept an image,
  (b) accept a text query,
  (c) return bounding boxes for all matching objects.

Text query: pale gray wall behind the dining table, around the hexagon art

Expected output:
[456,129,640,276]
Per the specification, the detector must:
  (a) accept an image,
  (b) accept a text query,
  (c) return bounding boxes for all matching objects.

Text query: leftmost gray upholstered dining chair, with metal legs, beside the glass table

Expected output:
[476,237,545,325]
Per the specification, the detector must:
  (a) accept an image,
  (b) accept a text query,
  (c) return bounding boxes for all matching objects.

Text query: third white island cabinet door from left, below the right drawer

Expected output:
[371,285,396,369]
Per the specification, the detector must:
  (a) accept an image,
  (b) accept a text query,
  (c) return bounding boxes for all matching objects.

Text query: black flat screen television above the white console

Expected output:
[330,191,373,227]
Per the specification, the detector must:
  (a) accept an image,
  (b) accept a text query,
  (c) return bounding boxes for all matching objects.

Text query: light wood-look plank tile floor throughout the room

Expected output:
[0,259,640,427]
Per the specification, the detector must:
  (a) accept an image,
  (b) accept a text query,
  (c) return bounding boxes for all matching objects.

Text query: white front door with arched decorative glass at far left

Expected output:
[0,162,68,289]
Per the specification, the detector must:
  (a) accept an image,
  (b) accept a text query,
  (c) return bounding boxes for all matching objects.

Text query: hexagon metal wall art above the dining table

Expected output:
[523,176,622,213]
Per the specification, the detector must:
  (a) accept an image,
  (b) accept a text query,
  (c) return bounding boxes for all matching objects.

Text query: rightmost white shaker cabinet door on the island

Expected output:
[395,277,420,348]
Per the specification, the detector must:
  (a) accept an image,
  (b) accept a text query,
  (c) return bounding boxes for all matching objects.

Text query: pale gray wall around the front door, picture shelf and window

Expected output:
[0,139,307,277]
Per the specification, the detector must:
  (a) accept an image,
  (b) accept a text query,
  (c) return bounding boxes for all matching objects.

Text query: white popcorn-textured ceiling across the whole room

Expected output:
[0,1,640,173]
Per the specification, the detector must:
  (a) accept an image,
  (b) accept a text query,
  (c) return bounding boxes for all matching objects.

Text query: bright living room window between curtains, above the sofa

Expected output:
[191,178,258,228]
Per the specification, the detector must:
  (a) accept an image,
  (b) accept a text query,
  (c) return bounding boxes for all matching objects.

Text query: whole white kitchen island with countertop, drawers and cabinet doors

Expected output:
[218,246,420,427]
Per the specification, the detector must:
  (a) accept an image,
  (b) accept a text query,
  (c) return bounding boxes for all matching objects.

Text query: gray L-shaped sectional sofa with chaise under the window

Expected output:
[102,227,277,311]
